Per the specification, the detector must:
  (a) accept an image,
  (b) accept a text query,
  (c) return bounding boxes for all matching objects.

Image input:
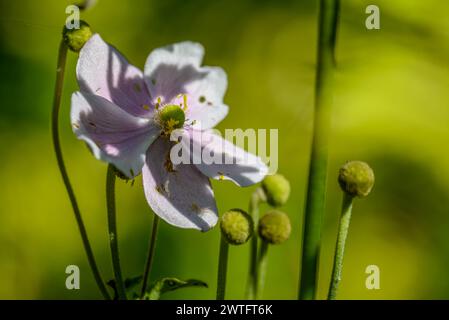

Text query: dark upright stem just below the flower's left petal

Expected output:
[106,164,126,300]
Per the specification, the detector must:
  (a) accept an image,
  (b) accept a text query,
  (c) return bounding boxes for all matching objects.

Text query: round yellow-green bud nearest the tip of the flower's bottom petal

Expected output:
[220,209,254,245]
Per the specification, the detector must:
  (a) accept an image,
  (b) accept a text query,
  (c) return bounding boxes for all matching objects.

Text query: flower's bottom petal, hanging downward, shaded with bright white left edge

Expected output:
[142,138,218,231]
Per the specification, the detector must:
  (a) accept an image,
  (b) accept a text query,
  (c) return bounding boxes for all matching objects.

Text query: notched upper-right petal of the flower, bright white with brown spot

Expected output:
[144,42,228,130]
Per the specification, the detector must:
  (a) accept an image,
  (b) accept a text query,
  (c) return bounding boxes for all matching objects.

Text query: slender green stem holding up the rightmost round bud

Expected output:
[328,193,353,300]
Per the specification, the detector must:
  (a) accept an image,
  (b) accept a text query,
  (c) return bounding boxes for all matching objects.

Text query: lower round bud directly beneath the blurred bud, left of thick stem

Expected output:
[258,210,292,244]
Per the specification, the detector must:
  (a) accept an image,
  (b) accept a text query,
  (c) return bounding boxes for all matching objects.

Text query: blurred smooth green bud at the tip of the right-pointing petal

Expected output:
[262,174,290,207]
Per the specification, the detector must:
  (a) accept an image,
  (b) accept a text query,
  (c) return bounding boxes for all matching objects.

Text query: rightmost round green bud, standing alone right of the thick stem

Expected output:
[338,161,374,197]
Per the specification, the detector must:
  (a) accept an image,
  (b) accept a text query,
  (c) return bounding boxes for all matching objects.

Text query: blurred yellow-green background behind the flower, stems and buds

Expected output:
[0,0,449,299]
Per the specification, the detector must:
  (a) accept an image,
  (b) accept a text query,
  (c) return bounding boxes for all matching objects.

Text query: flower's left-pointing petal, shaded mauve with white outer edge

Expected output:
[71,92,160,178]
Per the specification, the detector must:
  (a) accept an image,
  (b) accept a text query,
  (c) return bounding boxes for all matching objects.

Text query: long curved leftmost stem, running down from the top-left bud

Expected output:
[51,40,111,300]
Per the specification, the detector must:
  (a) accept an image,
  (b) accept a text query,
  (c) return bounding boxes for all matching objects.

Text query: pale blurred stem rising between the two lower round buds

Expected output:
[246,188,266,300]
